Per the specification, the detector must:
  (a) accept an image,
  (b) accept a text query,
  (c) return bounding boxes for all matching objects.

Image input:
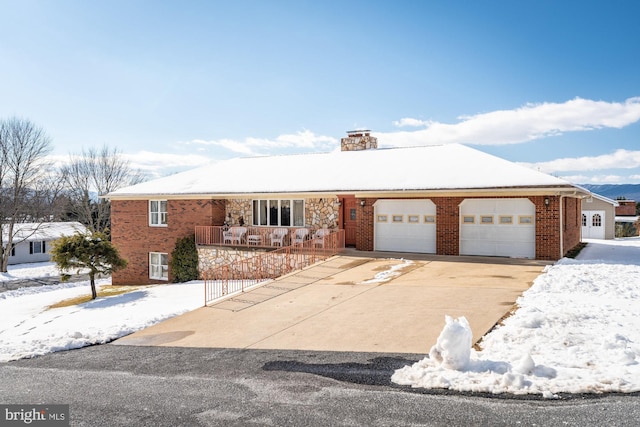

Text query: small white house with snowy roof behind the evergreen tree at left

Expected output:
[2,222,88,265]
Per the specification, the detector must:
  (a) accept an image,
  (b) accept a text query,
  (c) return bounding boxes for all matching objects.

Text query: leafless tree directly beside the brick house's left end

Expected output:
[61,145,144,235]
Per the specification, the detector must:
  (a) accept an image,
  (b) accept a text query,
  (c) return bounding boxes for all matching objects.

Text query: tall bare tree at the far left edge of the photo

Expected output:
[0,117,51,272]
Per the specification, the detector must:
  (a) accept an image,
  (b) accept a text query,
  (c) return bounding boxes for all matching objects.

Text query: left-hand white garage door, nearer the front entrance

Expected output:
[373,199,436,254]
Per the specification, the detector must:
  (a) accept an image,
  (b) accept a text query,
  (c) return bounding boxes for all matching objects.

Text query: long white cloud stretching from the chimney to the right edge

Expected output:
[376,97,640,147]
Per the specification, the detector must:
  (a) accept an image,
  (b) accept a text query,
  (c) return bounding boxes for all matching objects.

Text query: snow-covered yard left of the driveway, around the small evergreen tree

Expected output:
[0,263,204,362]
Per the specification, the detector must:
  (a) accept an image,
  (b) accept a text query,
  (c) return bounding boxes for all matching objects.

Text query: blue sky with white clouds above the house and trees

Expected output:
[0,0,640,184]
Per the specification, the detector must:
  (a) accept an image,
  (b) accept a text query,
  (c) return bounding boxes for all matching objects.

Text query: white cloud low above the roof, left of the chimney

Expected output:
[182,130,338,155]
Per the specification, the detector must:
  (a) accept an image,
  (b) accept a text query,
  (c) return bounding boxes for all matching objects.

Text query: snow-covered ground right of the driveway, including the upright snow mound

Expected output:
[392,238,640,398]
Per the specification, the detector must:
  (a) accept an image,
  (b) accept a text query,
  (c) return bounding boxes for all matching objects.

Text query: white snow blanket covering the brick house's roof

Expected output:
[107,144,573,198]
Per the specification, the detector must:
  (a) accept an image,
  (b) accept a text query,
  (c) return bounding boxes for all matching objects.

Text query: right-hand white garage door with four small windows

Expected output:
[460,199,536,258]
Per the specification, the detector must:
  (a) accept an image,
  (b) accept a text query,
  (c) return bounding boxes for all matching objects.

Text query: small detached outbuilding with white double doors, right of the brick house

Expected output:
[582,193,619,239]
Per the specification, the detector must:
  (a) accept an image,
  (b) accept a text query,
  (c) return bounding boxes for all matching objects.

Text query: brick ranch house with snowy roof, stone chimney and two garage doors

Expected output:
[107,131,590,285]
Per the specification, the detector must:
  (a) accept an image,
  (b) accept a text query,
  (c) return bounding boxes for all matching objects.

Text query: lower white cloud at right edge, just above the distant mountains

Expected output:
[521,149,640,173]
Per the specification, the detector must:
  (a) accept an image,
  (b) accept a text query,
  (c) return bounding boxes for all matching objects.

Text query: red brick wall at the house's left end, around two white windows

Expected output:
[111,200,225,285]
